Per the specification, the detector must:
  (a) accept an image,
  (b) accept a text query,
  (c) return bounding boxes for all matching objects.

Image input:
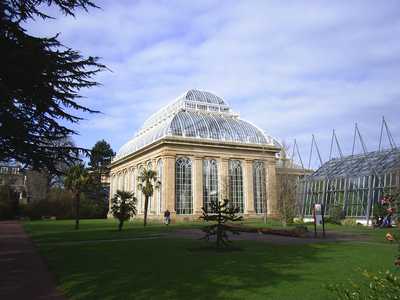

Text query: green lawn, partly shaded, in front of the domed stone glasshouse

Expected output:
[24,220,396,300]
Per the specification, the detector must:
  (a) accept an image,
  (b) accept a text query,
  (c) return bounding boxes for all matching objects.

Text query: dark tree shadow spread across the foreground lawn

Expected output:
[43,239,336,300]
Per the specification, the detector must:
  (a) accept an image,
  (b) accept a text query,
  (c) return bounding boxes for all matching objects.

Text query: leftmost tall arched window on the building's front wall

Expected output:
[175,157,193,214]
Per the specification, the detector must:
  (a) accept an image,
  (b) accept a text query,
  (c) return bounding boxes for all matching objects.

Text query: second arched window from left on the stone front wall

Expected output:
[203,159,218,210]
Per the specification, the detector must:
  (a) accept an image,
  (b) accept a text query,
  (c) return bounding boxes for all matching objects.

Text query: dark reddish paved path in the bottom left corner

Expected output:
[0,221,66,300]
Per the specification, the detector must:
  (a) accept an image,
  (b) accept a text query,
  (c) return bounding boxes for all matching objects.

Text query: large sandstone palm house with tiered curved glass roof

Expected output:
[110,90,280,219]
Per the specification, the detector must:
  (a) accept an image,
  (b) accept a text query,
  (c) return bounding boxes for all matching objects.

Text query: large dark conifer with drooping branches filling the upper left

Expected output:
[0,0,105,173]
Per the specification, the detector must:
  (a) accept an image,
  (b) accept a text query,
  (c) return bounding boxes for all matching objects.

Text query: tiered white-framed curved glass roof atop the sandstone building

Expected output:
[114,90,274,160]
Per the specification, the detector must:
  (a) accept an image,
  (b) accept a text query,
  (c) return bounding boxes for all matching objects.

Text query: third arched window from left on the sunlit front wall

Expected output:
[229,160,243,213]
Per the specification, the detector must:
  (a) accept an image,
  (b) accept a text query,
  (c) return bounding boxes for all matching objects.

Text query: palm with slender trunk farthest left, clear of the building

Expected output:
[64,164,89,229]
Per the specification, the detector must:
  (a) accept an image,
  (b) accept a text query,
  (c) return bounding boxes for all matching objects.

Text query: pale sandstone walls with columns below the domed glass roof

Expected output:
[110,138,279,219]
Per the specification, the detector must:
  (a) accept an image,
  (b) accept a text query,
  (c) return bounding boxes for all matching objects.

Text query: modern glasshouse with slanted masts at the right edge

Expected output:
[299,148,400,223]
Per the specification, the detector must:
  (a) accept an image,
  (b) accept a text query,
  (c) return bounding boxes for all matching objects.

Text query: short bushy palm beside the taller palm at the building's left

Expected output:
[111,190,136,231]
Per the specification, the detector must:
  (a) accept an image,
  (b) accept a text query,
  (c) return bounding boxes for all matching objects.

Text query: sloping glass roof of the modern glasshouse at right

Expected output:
[311,149,400,179]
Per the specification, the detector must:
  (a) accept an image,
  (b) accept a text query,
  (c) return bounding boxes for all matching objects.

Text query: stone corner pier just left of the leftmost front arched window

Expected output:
[163,155,175,216]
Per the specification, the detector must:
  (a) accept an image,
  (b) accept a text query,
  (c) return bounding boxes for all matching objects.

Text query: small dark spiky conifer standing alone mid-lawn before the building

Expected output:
[200,199,243,249]
